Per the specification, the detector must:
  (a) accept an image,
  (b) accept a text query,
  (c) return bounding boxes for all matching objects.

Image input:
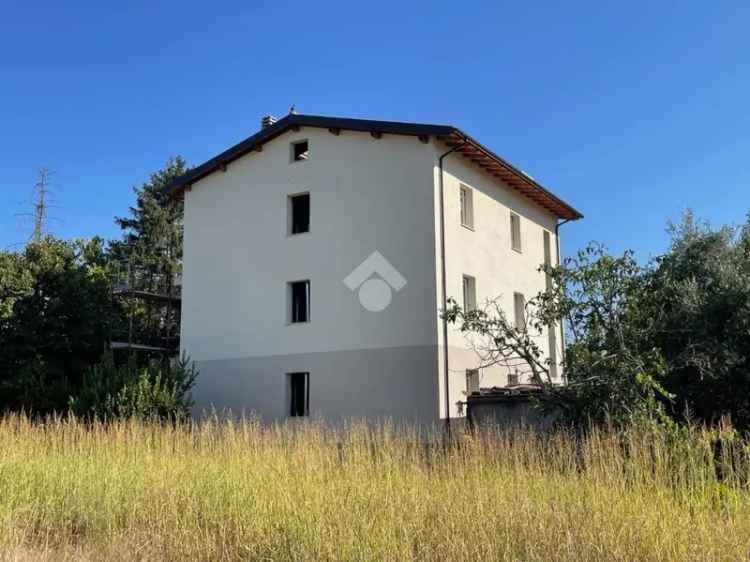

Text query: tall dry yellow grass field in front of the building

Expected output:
[0,416,750,562]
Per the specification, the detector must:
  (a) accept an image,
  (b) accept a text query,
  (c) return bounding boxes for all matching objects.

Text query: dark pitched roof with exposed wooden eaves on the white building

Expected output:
[165,114,583,220]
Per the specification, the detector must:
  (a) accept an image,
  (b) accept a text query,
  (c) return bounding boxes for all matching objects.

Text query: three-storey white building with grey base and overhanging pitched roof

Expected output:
[169,114,581,423]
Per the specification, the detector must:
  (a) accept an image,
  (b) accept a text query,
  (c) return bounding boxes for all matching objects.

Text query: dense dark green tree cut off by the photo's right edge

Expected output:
[646,212,750,429]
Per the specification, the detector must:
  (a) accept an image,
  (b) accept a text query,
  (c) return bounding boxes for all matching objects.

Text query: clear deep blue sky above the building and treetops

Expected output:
[0,0,750,258]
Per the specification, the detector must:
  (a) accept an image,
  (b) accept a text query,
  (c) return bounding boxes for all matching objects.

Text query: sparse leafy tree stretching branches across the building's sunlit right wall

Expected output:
[446,244,671,424]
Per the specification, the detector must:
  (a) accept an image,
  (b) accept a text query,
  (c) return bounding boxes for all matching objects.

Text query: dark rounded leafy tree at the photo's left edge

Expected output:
[0,236,115,413]
